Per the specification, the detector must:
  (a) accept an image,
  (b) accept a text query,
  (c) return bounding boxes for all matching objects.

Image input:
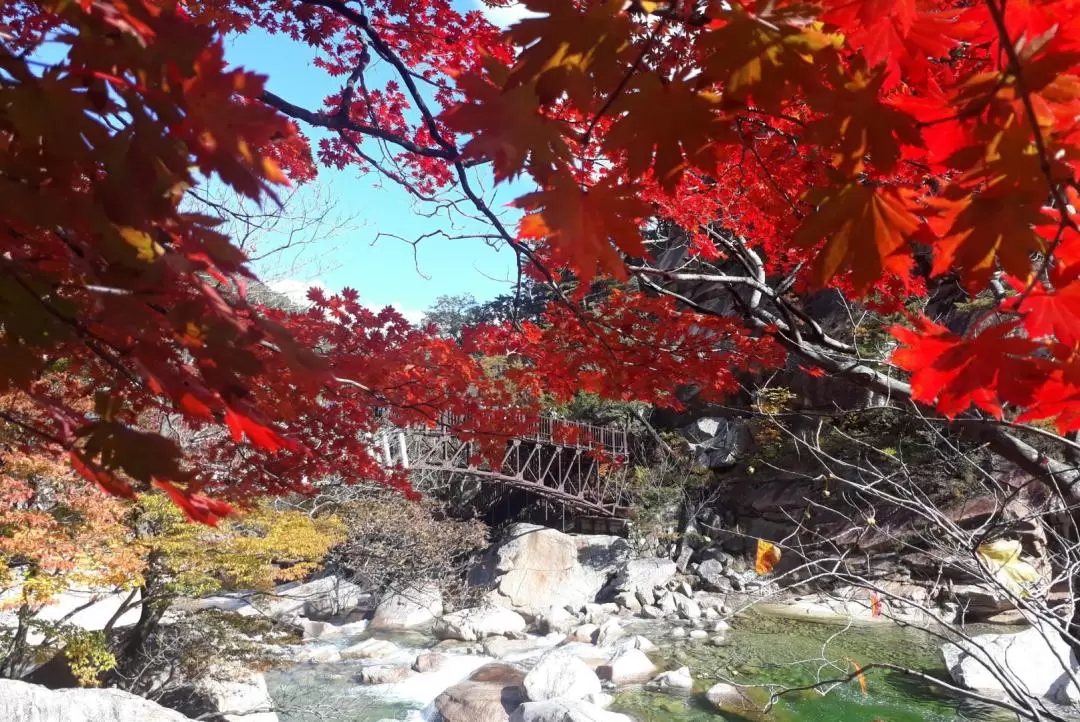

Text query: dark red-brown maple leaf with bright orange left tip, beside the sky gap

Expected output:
[516,171,651,283]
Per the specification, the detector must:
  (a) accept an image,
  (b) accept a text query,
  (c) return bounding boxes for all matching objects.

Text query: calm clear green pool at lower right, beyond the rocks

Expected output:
[612,616,1014,722]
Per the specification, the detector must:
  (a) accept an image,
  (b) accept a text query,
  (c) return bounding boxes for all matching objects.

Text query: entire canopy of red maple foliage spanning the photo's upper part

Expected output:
[6,0,1080,523]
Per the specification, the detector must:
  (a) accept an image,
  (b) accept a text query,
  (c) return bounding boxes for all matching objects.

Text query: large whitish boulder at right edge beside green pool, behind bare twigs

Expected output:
[942,625,1080,704]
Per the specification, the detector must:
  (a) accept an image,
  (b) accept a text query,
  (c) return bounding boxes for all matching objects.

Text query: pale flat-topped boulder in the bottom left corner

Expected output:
[0,680,190,722]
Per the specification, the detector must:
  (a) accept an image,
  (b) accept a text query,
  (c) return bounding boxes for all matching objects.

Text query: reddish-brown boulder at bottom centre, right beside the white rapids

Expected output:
[434,663,526,722]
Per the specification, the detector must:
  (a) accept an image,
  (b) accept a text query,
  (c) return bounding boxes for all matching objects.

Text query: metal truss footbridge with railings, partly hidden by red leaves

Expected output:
[374,414,630,519]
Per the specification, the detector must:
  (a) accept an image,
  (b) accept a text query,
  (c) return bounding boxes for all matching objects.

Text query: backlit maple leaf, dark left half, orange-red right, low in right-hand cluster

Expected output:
[795,182,920,294]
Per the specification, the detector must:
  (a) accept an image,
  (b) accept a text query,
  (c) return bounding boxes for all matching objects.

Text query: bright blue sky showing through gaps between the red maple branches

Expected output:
[227,0,533,318]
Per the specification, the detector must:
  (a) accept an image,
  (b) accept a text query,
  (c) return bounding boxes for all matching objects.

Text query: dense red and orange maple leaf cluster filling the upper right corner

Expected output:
[444,0,1080,433]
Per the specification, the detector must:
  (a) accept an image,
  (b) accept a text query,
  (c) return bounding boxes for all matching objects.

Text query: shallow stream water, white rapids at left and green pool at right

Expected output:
[267,615,1014,722]
